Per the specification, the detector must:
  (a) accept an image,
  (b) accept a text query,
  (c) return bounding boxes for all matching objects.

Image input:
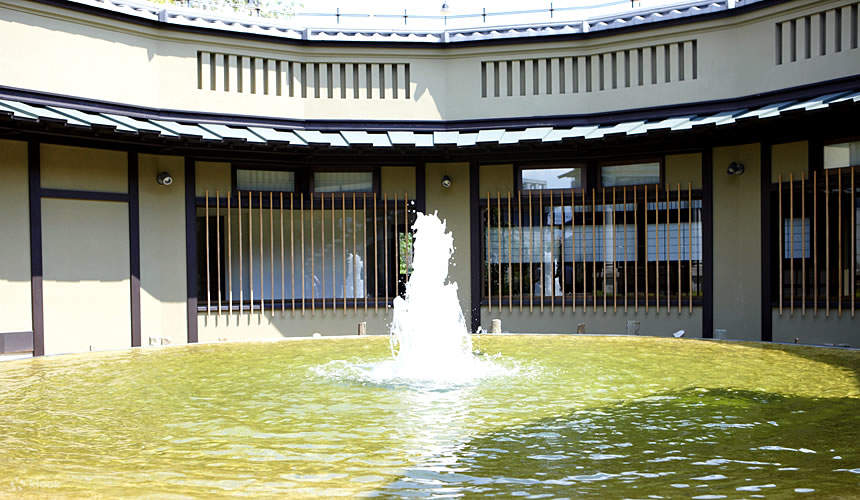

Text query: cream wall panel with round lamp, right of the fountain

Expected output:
[713,144,762,340]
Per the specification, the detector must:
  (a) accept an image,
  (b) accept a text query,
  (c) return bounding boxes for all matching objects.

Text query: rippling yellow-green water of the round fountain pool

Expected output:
[0,336,860,498]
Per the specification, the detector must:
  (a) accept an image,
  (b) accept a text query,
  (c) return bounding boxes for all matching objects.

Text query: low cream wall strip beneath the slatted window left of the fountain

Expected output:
[197,307,391,342]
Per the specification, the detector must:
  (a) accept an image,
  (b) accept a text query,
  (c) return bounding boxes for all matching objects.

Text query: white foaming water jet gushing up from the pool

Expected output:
[320,212,518,387]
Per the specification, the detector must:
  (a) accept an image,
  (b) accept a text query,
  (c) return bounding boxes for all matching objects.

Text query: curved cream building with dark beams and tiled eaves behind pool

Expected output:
[0,0,860,355]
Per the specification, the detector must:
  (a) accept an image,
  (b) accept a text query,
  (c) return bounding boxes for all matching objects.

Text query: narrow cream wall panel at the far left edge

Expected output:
[0,140,33,333]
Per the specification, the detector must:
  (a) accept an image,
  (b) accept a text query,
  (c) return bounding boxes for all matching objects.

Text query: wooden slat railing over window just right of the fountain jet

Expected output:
[481,184,703,312]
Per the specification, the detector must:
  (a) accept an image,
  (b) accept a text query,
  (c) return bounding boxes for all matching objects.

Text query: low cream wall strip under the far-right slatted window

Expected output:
[773,309,860,347]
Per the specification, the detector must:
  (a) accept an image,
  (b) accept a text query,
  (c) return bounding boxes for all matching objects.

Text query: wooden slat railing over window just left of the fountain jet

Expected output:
[197,191,415,315]
